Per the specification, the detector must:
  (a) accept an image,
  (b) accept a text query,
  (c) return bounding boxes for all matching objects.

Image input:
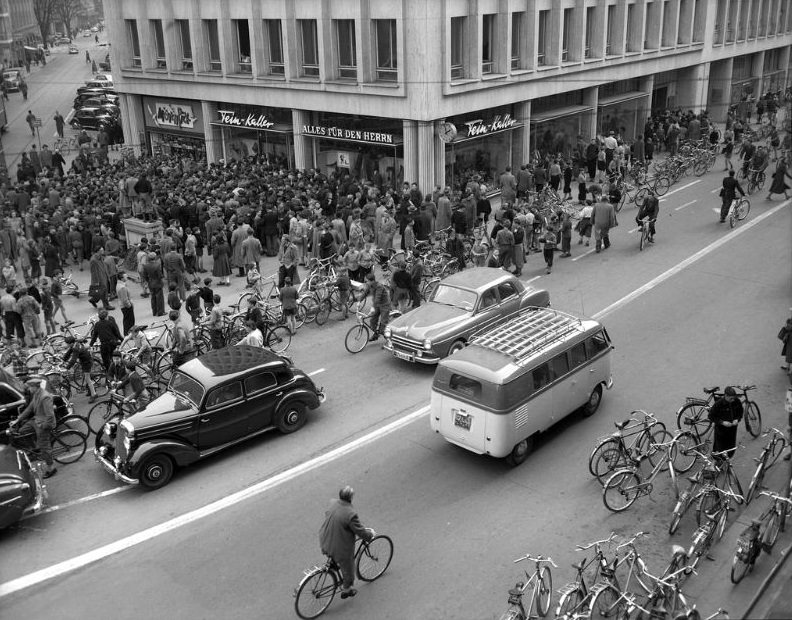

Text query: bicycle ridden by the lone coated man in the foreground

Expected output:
[294,534,393,620]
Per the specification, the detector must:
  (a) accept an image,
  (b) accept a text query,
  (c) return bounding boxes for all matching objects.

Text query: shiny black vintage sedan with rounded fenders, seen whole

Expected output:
[94,345,324,489]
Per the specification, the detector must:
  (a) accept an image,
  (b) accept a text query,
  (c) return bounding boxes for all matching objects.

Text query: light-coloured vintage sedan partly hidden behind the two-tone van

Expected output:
[384,267,550,364]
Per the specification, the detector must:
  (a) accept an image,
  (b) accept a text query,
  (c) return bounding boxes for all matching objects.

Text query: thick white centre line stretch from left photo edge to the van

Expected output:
[0,405,429,598]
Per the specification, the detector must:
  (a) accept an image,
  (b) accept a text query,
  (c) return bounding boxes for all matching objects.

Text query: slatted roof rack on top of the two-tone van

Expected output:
[470,306,583,365]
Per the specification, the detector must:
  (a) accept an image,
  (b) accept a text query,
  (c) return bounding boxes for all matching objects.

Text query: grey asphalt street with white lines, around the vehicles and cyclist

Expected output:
[0,123,792,620]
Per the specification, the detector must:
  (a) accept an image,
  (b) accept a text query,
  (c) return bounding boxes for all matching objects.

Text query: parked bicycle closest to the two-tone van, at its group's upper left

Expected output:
[589,409,671,484]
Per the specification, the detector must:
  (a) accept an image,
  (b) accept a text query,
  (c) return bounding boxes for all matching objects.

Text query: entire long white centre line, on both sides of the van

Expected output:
[0,199,792,598]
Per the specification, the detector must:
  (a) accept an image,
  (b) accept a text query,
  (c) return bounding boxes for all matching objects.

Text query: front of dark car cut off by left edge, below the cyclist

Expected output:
[0,446,47,529]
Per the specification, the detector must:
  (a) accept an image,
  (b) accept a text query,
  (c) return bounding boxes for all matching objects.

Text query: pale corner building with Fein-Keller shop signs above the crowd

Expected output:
[105,0,792,191]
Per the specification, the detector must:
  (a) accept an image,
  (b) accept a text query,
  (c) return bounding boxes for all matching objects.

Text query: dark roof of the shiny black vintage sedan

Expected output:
[179,345,285,388]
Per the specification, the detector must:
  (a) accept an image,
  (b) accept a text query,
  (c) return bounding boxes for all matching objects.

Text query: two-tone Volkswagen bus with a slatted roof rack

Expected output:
[430,307,613,465]
